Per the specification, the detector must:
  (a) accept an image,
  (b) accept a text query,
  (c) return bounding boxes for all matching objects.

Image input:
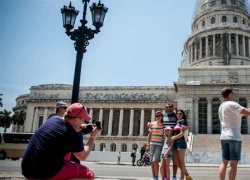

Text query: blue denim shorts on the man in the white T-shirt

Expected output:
[220,140,242,161]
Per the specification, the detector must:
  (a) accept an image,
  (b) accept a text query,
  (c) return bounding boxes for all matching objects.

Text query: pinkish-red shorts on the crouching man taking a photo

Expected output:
[48,160,94,180]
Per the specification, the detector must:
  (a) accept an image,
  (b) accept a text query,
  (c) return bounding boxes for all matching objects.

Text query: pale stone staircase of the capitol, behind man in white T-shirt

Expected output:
[188,133,250,153]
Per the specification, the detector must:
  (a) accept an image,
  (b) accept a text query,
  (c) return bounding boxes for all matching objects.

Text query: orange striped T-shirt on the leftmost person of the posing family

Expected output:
[149,121,163,146]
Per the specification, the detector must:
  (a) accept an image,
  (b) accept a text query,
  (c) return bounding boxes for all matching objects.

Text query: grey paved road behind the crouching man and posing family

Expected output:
[0,160,250,180]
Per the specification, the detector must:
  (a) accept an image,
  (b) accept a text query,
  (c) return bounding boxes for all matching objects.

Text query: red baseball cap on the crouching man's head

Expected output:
[66,103,91,122]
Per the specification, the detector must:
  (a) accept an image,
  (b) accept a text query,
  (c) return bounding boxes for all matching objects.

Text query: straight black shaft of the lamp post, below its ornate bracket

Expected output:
[71,50,83,104]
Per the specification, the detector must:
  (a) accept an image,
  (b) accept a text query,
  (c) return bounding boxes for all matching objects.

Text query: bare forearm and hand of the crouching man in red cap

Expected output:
[74,127,102,160]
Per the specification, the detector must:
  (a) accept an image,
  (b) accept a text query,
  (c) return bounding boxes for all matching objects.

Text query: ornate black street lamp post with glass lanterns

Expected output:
[61,0,108,104]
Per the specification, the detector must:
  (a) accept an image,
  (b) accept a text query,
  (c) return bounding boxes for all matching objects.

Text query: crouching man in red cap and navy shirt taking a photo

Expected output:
[21,103,102,180]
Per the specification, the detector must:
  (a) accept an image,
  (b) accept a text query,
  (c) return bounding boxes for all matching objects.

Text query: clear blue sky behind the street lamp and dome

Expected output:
[0,0,196,110]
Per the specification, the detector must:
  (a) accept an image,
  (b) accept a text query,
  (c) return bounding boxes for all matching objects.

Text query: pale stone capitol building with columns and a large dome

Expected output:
[13,0,250,162]
